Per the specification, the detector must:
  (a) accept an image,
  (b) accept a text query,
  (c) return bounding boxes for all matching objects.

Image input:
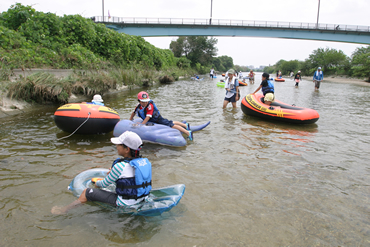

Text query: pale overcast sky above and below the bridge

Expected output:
[0,0,370,67]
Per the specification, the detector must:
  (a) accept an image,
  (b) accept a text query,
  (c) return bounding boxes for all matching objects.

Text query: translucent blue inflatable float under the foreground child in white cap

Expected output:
[68,168,185,216]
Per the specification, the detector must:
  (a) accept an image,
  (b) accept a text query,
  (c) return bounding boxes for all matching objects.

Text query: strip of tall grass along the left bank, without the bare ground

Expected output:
[0,66,194,104]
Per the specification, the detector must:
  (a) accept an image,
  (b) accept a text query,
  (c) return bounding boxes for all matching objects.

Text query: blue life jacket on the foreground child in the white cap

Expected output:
[112,158,152,200]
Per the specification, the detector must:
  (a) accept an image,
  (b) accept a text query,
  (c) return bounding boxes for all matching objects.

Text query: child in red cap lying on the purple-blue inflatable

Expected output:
[130,91,193,141]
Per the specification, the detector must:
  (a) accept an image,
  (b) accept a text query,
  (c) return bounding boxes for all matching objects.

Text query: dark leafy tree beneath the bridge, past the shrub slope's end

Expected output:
[170,36,217,66]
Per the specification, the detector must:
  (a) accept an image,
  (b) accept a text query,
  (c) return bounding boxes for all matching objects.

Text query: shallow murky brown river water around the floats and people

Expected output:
[0,74,370,246]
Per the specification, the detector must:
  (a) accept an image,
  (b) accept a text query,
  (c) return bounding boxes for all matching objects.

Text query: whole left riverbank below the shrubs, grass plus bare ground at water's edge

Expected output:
[0,67,193,118]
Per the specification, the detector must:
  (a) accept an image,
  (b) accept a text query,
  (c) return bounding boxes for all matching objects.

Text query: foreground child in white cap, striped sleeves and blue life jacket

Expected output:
[51,131,152,214]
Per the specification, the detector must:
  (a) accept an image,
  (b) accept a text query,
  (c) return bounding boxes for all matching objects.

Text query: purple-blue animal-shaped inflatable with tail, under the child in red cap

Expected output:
[113,118,211,147]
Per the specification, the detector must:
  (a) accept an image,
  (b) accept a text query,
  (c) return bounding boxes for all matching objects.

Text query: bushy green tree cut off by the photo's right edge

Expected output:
[352,46,370,82]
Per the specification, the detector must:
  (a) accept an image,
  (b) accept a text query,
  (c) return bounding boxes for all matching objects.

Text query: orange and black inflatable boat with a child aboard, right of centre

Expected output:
[241,94,320,124]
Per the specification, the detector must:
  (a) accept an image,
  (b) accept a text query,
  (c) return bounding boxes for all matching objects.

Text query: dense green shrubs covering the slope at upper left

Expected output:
[0,3,177,70]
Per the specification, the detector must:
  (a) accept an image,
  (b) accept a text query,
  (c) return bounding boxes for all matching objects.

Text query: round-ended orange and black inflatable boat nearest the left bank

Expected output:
[54,103,120,134]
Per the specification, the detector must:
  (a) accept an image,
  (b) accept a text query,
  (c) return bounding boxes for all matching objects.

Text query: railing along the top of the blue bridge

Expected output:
[91,16,370,32]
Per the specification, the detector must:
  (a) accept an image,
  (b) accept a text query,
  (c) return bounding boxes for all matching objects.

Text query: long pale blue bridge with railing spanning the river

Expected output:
[91,16,370,44]
